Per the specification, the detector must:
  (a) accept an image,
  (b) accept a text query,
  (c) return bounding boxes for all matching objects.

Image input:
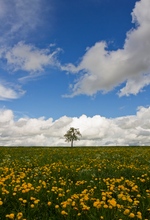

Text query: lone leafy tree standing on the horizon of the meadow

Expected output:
[64,127,82,147]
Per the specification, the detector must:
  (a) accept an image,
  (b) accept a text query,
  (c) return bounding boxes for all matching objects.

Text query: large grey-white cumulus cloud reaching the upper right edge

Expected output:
[62,0,150,96]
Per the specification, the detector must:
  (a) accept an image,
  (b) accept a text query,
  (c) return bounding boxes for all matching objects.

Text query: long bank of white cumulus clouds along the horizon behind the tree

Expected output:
[0,107,150,146]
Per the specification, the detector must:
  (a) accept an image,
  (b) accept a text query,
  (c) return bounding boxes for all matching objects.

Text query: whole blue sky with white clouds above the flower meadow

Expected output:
[0,0,150,146]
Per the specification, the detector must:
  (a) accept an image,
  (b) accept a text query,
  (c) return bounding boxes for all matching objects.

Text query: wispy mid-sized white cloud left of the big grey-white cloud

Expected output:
[3,42,59,74]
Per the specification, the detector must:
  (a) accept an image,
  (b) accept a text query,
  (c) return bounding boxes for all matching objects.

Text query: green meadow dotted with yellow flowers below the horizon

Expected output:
[0,147,150,220]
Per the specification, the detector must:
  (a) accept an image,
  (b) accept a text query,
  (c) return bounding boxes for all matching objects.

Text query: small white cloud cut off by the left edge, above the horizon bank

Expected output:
[0,83,25,100]
